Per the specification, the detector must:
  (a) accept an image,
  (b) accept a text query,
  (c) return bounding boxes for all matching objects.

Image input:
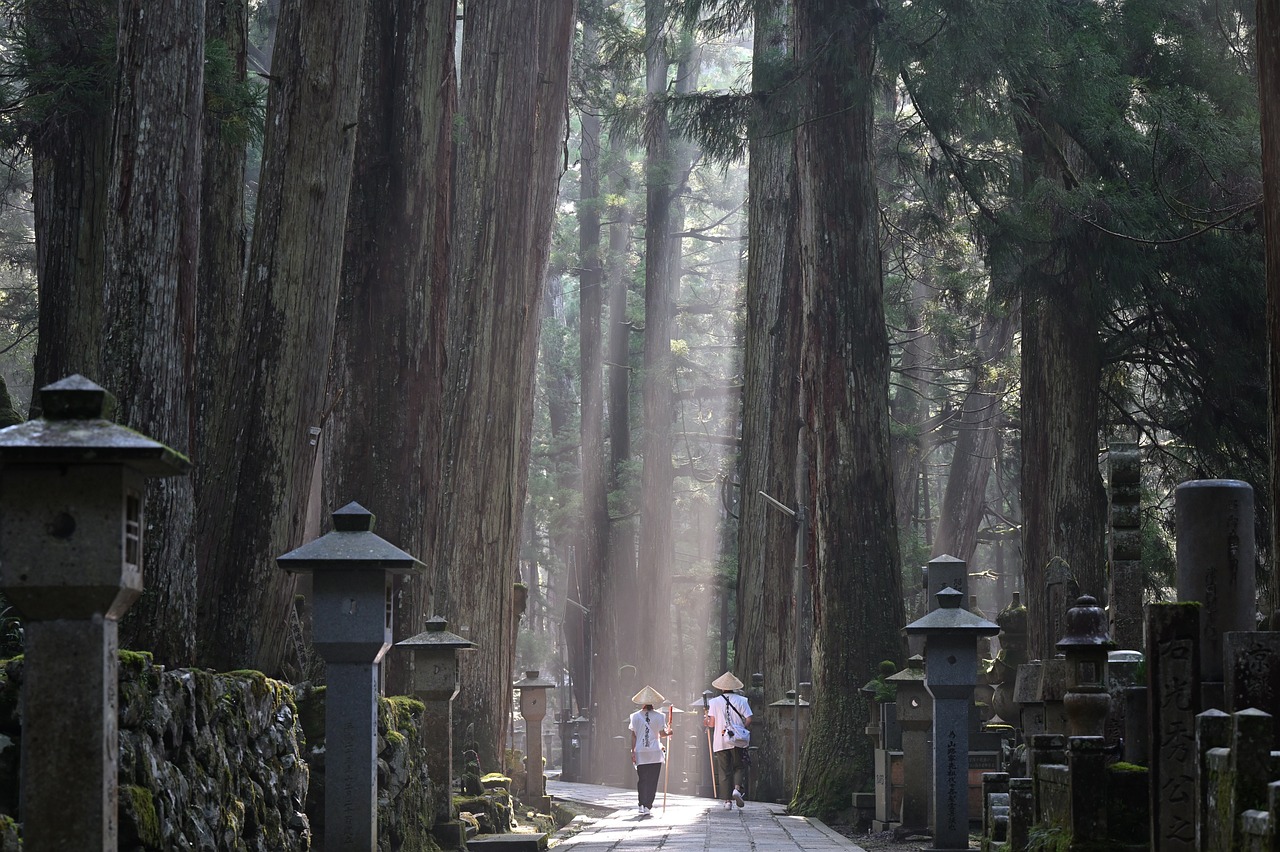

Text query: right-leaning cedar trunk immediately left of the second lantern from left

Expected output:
[197,0,365,674]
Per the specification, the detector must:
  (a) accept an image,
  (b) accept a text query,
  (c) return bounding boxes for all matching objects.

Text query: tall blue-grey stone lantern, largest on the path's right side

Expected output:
[902,586,1000,852]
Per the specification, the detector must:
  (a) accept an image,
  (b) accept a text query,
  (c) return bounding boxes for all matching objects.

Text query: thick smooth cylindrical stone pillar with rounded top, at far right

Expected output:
[1174,480,1257,707]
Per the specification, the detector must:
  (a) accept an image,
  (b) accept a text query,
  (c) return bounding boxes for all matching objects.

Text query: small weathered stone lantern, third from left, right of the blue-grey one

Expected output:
[396,615,476,849]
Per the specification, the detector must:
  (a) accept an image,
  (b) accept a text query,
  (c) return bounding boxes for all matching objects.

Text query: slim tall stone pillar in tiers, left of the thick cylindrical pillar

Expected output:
[1107,443,1142,650]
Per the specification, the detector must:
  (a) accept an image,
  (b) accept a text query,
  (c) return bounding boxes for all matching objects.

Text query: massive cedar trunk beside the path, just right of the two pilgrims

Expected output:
[792,0,902,817]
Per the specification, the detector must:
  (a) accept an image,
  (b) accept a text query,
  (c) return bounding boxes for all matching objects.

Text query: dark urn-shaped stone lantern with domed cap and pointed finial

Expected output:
[1057,595,1115,737]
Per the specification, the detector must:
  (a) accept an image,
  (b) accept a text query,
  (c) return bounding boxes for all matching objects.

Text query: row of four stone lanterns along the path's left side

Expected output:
[0,376,554,852]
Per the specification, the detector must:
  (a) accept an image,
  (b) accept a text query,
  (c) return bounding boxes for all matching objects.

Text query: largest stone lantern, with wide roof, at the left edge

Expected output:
[0,376,189,852]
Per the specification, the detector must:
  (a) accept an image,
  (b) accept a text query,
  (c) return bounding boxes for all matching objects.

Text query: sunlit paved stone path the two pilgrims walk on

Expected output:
[547,779,864,852]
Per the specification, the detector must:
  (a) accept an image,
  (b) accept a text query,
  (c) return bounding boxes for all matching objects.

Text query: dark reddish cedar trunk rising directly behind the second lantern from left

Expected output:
[324,0,457,695]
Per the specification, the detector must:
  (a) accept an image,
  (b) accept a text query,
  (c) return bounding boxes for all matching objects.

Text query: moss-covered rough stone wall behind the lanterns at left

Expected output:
[0,651,438,852]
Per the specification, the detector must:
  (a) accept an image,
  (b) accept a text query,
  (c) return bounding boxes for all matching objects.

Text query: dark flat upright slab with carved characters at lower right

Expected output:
[1147,604,1201,852]
